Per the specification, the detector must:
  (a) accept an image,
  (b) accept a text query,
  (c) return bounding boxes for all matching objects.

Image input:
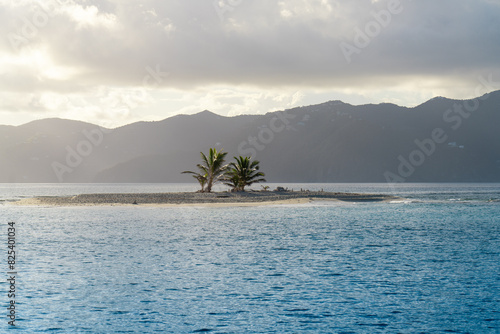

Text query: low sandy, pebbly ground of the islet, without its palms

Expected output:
[12,191,400,207]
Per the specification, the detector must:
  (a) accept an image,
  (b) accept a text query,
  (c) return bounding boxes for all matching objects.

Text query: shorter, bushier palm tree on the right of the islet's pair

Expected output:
[224,156,266,191]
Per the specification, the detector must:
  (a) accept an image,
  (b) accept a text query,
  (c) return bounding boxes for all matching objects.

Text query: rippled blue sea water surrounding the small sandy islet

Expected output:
[0,184,500,333]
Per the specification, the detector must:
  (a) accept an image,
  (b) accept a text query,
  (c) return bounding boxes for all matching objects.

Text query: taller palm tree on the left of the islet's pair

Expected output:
[182,148,228,192]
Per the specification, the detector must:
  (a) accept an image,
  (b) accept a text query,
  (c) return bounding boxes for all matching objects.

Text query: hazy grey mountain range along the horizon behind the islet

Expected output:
[0,91,500,183]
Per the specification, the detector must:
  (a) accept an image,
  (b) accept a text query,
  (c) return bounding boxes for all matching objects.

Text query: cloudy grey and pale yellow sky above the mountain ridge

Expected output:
[0,0,500,127]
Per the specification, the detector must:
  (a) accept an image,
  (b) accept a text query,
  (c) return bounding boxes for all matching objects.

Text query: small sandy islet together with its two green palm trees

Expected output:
[16,148,398,206]
